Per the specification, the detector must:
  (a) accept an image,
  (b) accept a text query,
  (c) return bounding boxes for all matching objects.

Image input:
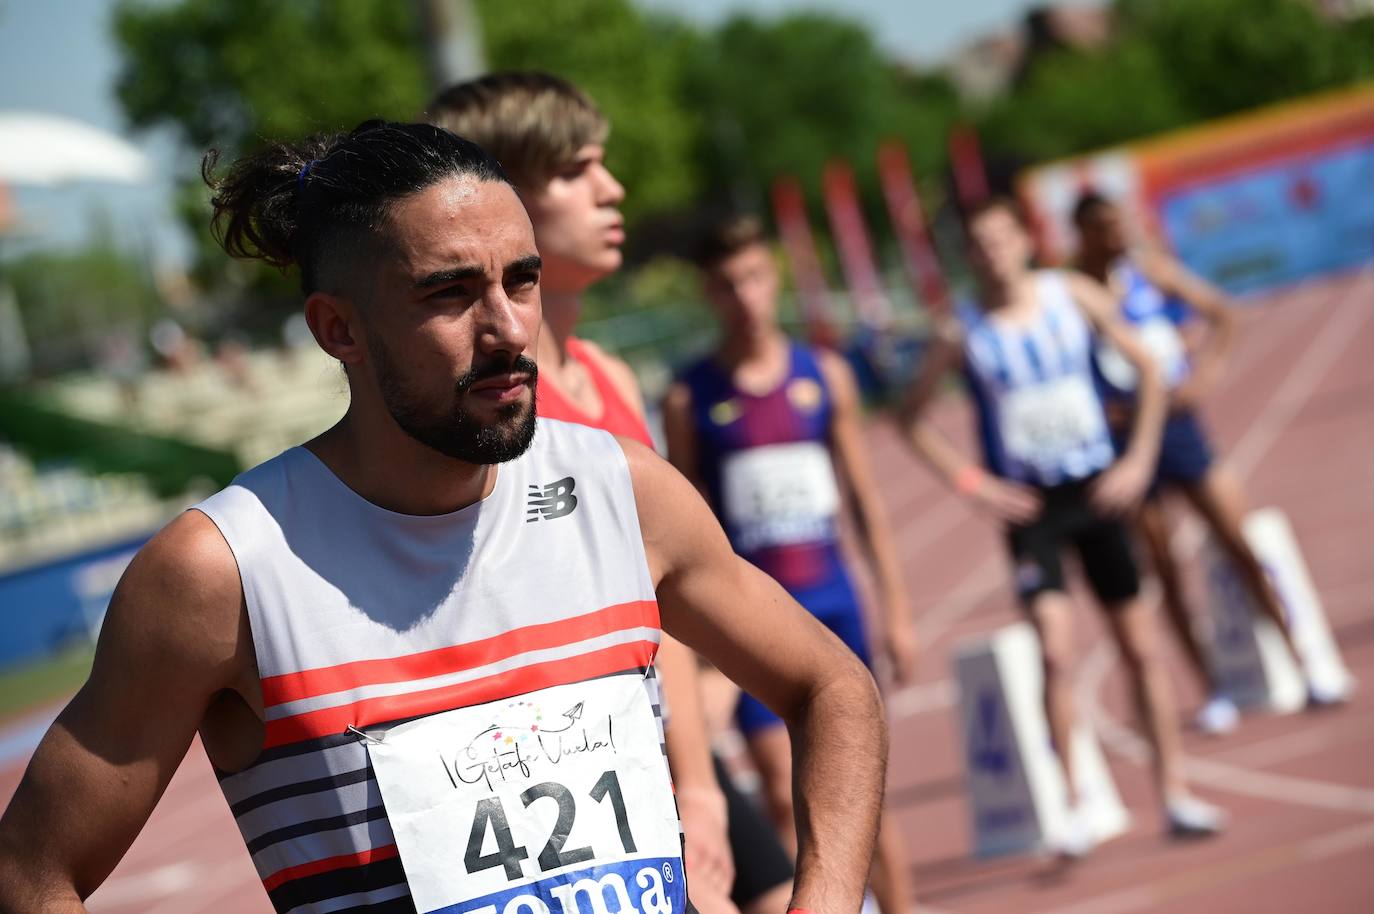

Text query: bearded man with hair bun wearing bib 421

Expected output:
[0,121,886,914]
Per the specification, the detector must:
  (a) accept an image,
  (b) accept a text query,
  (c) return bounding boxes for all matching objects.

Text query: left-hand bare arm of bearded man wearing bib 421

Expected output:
[0,511,253,914]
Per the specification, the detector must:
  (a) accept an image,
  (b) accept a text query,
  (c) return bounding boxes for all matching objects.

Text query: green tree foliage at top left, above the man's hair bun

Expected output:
[114,0,427,154]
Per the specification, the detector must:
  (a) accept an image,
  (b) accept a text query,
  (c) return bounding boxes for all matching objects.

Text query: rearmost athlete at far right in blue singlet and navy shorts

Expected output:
[1073,192,1345,733]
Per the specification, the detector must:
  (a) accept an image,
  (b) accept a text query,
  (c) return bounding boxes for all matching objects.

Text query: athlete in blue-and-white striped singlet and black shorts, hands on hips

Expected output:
[903,199,1221,856]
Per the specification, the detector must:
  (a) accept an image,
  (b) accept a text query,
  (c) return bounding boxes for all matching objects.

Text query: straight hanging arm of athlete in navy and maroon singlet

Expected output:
[820,350,916,684]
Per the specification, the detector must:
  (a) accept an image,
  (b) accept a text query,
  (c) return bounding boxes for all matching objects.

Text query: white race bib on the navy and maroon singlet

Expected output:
[720,441,840,553]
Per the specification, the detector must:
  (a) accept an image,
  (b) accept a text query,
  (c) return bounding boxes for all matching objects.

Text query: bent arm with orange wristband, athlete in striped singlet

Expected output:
[897,319,1040,524]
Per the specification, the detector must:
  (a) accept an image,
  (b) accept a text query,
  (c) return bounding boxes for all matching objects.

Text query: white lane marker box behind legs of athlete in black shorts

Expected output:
[955,623,1131,858]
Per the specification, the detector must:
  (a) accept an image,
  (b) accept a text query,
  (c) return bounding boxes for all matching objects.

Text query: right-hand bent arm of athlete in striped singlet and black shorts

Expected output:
[1065,272,1167,514]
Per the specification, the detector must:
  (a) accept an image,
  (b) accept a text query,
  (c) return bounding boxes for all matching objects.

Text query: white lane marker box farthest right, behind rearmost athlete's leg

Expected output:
[1206,507,1353,713]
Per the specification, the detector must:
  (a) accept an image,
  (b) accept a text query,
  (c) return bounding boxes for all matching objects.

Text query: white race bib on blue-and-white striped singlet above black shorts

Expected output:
[1002,375,1106,467]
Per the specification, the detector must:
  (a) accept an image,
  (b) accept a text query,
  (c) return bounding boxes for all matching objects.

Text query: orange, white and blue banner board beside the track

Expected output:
[1018,85,1374,293]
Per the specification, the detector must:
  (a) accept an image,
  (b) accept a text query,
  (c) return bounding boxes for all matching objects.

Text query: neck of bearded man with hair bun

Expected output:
[305,404,497,515]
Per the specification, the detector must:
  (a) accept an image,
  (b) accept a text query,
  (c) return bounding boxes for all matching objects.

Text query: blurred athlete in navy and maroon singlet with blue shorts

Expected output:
[664,217,916,914]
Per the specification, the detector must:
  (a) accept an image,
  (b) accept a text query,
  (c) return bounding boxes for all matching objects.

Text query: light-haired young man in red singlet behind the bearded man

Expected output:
[426,71,793,914]
